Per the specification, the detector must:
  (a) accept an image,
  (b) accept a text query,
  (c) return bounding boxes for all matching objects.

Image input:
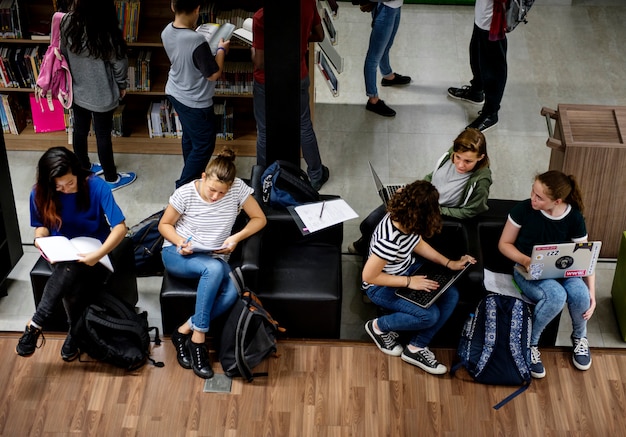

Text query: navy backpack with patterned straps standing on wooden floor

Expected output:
[450,294,532,410]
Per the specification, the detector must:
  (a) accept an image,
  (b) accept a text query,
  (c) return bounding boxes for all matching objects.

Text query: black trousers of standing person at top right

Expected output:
[469,24,508,114]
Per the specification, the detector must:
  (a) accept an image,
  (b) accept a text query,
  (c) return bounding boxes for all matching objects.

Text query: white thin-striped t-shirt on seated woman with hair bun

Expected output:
[163,178,254,261]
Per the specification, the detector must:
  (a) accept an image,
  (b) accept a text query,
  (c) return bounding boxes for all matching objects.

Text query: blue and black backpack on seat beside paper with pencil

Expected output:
[261,160,320,208]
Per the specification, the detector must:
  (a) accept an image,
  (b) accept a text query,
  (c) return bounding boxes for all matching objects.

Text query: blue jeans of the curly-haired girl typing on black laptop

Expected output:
[367,262,459,347]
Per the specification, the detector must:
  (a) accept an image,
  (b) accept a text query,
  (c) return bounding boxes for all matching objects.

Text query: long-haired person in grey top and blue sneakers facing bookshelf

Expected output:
[60,0,137,190]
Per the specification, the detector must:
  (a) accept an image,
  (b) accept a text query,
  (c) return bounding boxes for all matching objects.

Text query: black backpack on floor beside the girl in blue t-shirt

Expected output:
[71,293,163,370]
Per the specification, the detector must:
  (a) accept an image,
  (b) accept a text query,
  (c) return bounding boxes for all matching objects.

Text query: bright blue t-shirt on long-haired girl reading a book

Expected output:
[30,176,124,243]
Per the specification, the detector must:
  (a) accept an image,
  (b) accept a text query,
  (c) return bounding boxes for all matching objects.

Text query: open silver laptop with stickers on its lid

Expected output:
[515,241,602,281]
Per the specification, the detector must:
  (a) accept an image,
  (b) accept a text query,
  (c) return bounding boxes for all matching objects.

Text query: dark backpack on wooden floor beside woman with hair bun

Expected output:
[218,268,284,382]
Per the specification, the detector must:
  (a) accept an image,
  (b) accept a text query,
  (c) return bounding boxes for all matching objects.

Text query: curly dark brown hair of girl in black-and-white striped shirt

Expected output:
[387,180,442,238]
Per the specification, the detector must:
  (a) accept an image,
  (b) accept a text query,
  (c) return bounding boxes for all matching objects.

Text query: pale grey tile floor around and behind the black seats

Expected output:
[0,0,626,347]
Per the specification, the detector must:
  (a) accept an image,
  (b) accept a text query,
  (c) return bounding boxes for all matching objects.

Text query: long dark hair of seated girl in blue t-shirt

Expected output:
[35,147,91,230]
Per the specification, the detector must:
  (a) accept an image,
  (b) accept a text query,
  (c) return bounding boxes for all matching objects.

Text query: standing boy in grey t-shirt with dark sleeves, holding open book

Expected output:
[161,0,230,188]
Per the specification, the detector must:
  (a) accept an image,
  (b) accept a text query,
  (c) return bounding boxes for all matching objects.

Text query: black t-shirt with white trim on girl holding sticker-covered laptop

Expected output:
[509,199,587,256]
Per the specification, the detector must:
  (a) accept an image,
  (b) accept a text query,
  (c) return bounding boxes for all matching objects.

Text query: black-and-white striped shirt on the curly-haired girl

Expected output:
[369,213,421,275]
